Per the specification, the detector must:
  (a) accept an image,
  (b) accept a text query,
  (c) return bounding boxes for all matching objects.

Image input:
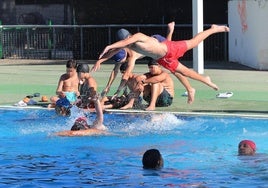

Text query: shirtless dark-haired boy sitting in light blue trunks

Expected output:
[49,60,80,108]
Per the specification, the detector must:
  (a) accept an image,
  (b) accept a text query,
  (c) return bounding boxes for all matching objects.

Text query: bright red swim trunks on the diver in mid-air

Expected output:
[157,40,187,73]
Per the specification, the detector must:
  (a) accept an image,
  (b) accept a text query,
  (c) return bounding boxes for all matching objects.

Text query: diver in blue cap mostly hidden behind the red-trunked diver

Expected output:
[92,22,176,97]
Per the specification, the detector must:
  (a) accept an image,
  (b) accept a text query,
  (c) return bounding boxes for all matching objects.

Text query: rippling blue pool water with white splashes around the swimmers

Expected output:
[0,108,268,188]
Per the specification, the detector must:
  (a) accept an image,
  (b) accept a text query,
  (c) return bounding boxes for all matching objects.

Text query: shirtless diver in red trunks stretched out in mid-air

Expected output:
[99,25,229,103]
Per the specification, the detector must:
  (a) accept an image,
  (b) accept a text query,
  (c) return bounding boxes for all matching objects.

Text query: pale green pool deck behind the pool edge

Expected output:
[0,59,268,117]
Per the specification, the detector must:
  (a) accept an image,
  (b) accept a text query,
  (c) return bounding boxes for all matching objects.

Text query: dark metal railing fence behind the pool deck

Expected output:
[0,24,228,61]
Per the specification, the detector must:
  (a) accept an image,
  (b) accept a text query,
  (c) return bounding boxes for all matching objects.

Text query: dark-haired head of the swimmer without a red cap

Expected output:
[142,149,164,169]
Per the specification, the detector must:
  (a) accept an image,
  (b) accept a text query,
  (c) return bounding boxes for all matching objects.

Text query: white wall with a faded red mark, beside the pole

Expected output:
[228,0,268,70]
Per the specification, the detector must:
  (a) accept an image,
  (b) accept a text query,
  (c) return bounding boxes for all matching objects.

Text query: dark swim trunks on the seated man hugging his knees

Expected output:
[143,89,173,107]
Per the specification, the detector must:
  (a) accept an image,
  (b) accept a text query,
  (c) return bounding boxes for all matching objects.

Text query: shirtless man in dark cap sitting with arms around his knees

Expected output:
[142,60,174,110]
